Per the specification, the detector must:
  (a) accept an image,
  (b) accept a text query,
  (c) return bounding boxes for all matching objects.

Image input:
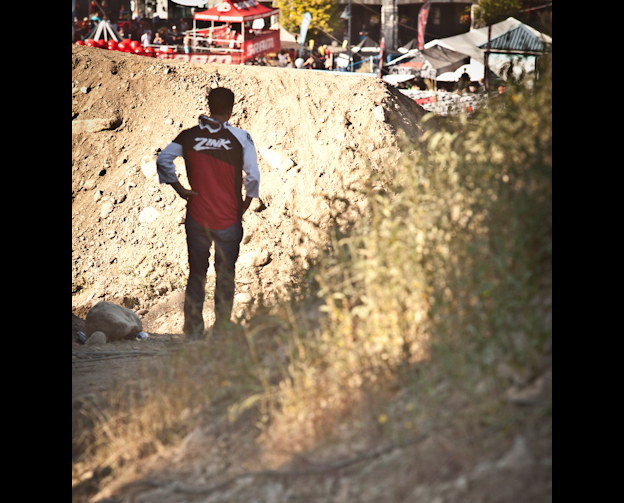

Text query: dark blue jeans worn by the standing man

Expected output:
[184,215,243,338]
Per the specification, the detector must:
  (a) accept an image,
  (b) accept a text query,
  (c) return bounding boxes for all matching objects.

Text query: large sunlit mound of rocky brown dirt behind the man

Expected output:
[72,46,424,333]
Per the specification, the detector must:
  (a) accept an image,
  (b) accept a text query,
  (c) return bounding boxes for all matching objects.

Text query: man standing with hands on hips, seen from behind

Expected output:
[157,87,260,340]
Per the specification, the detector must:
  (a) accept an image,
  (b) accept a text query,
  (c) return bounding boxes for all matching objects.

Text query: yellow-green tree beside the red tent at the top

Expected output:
[277,0,340,36]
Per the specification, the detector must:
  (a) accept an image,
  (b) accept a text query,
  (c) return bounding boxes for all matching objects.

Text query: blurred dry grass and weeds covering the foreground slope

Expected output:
[72,55,552,492]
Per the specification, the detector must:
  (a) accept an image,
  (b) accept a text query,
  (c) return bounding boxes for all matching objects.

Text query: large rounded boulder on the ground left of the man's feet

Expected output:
[85,302,143,341]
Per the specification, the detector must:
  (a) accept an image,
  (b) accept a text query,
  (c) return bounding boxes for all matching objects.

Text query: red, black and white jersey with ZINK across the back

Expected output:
[157,115,260,230]
